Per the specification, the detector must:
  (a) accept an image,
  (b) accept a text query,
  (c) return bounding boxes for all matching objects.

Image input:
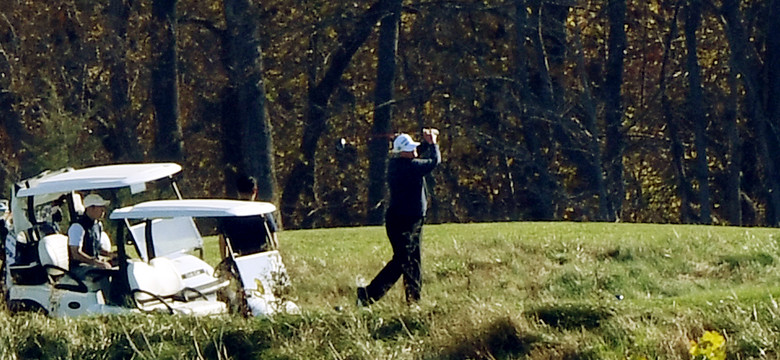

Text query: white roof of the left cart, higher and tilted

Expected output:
[16,163,181,197]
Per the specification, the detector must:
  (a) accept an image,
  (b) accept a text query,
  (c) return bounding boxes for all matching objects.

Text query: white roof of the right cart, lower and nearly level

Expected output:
[110,199,276,220]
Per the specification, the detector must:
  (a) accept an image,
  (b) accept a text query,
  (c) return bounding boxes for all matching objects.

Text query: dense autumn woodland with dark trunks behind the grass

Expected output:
[0,0,780,228]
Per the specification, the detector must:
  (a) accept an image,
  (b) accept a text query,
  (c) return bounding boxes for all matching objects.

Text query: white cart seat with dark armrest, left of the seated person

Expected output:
[38,234,91,293]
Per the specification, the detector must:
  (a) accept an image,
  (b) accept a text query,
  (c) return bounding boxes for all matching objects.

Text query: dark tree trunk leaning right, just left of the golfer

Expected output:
[281,3,381,227]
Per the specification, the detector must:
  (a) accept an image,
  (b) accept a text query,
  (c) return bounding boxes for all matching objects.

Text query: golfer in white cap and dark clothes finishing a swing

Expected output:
[357,129,441,306]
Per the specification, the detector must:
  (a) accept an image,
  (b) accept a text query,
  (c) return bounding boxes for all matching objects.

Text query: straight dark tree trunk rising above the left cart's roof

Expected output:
[149,0,183,161]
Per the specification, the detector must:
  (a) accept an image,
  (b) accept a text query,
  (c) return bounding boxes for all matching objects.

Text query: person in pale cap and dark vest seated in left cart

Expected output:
[68,194,115,278]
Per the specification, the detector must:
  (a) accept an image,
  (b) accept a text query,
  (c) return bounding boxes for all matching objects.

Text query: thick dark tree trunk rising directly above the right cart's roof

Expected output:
[223,0,276,202]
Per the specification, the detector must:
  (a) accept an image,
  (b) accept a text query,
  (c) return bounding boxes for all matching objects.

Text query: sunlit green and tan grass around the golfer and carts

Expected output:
[0,222,780,359]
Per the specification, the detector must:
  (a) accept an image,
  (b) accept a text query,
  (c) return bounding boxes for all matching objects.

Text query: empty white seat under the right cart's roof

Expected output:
[127,258,227,315]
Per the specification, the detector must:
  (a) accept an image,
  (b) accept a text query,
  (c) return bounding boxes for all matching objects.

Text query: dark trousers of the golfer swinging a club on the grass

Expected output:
[366,214,424,303]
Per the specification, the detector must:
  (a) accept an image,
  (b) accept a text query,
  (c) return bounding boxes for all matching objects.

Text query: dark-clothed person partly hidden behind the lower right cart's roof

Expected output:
[219,176,278,259]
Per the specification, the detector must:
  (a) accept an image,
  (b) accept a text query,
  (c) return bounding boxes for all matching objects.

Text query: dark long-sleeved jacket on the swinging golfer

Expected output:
[387,143,441,216]
